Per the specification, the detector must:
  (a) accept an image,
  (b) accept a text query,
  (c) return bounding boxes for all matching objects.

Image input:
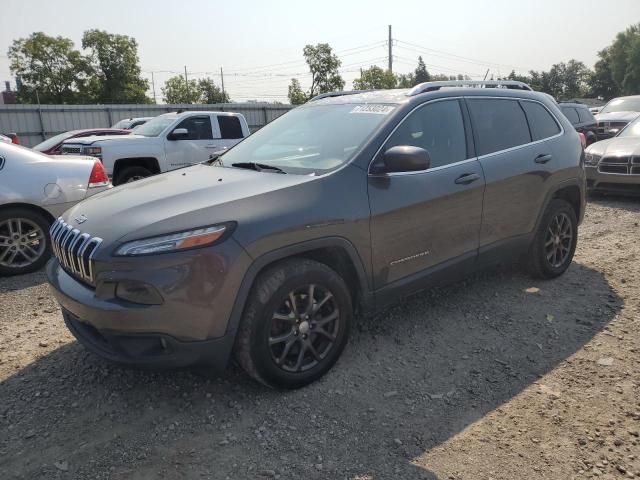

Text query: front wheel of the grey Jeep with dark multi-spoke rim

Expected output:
[235,258,353,389]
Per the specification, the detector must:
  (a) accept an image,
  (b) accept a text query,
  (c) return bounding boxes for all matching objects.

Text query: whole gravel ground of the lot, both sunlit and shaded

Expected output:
[0,199,640,480]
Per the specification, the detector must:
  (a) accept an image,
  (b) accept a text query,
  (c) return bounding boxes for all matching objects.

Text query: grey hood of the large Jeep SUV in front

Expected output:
[63,165,318,247]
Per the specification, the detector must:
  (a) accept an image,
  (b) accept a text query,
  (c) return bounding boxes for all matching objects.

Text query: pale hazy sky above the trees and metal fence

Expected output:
[0,0,640,103]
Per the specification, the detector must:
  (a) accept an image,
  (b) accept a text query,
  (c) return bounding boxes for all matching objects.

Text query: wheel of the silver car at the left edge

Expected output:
[0,208,51,275]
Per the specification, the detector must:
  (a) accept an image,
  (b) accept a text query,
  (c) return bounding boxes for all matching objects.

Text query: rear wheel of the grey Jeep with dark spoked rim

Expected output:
[528,198,578,279]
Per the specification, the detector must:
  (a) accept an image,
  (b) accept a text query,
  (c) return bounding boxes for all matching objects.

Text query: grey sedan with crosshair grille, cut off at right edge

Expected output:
[585,113,640,194]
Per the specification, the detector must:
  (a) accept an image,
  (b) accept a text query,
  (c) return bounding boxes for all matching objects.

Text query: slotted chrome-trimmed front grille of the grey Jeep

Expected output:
[49,218,102,285]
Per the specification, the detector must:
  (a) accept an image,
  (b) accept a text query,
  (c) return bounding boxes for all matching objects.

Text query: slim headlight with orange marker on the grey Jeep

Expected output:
[116,225,231,256]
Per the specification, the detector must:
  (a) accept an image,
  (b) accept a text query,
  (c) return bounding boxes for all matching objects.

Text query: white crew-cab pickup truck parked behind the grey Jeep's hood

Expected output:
[62,111,249,185]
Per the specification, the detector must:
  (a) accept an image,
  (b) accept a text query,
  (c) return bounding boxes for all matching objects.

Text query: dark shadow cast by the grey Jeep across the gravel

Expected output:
[0,264,622,480]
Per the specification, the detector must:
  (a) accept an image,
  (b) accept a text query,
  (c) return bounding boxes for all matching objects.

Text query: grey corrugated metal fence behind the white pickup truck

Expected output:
[0,103,292,147]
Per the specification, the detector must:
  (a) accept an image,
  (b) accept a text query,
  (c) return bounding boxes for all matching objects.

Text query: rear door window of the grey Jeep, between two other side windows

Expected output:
[467,98,531,155]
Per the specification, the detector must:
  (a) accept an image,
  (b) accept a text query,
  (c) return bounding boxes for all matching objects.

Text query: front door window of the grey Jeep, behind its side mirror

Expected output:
[385,100,467,168]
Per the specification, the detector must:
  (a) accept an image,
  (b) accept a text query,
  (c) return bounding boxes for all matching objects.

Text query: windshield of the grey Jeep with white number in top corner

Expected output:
[216,104,395,175]
